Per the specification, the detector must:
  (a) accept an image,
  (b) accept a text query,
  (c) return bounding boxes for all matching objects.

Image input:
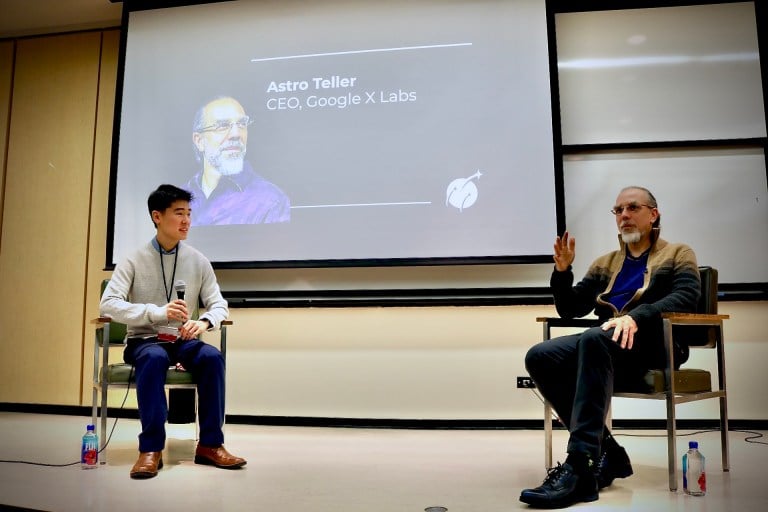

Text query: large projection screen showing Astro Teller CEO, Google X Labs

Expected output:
[108,0,561,267]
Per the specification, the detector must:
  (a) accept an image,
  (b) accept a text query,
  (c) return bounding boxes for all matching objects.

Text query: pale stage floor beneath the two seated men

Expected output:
[0,413,768,512]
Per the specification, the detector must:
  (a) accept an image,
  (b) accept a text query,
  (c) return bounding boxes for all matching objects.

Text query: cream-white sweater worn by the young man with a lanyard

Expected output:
[100,240,229,336]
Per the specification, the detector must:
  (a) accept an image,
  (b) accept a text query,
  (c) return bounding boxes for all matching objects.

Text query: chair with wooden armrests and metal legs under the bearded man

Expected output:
[536,267,730,491]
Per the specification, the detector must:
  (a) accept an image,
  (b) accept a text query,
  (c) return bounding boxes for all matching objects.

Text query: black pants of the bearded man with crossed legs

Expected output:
[525,327,664,460]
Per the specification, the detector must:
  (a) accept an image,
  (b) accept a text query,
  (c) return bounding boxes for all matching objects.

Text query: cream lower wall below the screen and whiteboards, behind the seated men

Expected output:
[220,302,768,419]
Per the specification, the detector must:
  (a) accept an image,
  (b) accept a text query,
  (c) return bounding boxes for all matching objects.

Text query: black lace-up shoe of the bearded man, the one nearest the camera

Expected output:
[520,454,598,508]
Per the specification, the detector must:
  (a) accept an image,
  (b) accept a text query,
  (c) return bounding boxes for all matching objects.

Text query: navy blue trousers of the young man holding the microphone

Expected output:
[123,338,224,452]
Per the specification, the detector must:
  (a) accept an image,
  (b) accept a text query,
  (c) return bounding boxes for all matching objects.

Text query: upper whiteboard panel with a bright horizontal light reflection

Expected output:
[555,2,766,145]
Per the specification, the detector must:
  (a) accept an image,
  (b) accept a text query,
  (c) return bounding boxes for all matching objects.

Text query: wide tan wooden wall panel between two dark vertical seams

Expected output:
[0,32,101,405]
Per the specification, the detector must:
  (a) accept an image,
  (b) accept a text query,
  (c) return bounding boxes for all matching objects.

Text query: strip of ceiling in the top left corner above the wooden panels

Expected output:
[0,0,123,39]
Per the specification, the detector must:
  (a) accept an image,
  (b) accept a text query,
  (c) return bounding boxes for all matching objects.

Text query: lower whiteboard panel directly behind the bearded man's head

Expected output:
[563,149,768,283]
